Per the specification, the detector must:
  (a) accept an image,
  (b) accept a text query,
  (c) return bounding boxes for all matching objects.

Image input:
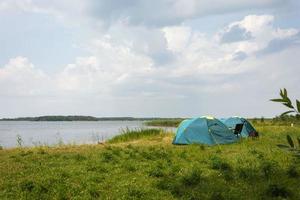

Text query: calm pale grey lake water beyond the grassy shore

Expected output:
[0,121,173,148]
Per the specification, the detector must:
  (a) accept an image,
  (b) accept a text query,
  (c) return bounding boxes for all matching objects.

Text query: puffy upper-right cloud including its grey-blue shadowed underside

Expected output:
[216,15,299,59]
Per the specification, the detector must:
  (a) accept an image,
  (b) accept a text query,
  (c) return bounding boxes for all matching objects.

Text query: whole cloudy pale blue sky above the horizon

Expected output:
[0,0,300,118]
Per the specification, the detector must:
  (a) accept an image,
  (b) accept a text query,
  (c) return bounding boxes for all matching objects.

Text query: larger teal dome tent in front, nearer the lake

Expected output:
[173,117,238,145]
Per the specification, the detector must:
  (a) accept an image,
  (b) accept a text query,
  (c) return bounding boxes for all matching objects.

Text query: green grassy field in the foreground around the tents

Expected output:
[0,125,300,200]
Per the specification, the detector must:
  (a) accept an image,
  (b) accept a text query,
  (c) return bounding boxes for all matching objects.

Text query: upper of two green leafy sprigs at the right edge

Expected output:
[270,88,300,116]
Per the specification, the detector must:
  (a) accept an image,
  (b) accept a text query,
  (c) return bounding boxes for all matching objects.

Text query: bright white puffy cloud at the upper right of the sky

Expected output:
[216,15,299,56]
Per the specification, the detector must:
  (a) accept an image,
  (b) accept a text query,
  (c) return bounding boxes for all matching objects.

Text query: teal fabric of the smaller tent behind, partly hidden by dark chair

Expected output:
[221,117,257,137]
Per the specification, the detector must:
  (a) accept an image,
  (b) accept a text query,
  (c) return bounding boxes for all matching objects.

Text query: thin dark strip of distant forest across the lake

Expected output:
[0,115,183,121]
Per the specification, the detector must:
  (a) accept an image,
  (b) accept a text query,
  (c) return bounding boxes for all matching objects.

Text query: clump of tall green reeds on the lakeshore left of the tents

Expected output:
[107,128,164,143]
